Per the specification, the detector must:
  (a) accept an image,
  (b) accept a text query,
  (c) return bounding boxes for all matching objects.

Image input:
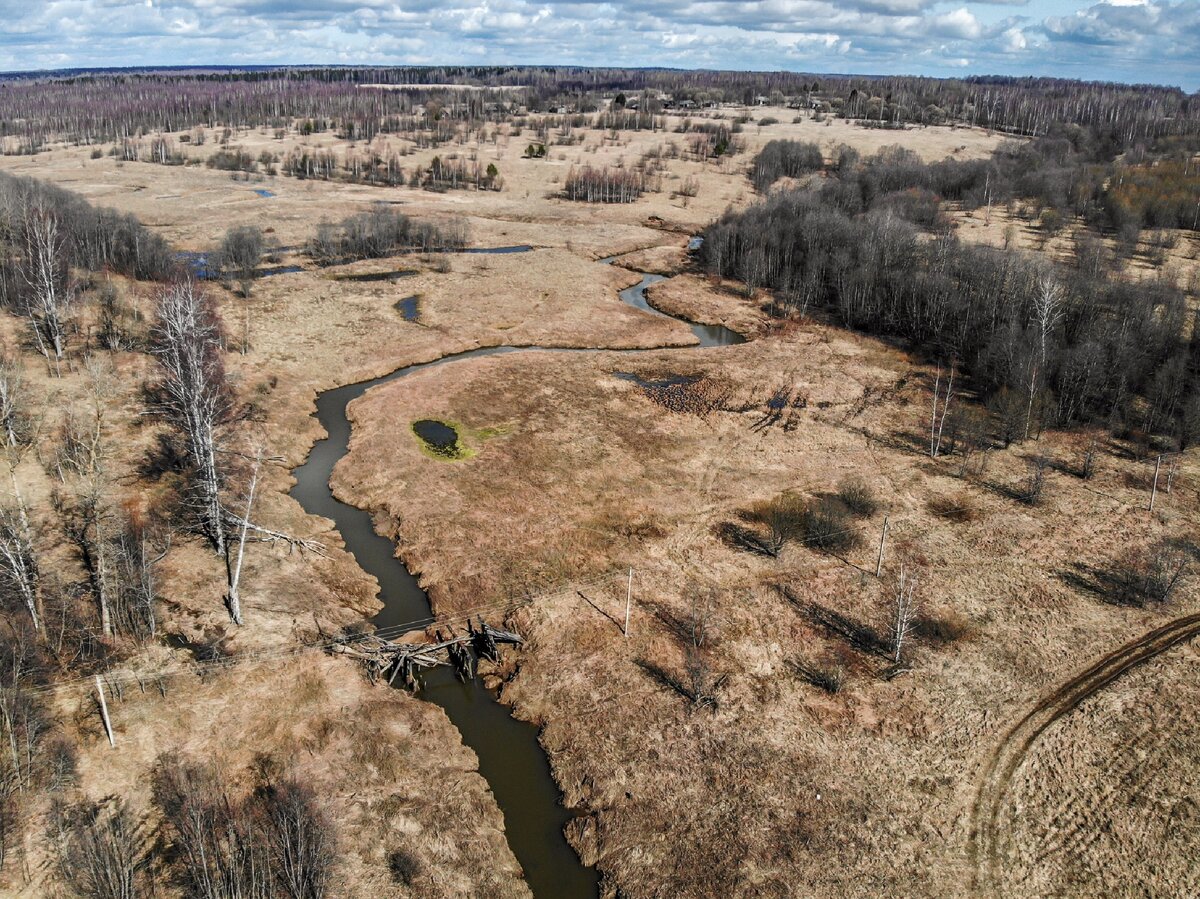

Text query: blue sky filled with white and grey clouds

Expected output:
[0,0,1200,91]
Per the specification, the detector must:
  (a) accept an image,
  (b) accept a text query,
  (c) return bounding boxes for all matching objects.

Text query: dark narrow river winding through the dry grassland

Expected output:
[292,247,744,899]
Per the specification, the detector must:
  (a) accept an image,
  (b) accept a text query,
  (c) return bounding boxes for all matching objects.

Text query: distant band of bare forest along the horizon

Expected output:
[0,66,1200,152]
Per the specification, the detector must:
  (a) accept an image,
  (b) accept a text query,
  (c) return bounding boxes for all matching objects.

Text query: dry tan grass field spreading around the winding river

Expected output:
[0,108,1200,899]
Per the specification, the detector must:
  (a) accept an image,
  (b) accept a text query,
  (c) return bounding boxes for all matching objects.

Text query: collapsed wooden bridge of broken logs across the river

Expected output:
[328,618,524,691]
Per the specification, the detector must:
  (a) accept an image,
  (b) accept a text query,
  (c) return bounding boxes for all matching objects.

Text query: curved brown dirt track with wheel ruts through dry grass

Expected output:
[968,613,1200,895]
